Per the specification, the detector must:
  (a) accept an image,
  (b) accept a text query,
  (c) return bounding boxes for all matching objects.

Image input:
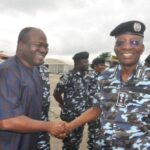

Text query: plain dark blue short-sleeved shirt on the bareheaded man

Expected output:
[0,56,42,150]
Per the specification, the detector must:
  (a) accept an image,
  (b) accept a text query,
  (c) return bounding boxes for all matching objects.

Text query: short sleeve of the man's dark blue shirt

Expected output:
[0,69,23,120]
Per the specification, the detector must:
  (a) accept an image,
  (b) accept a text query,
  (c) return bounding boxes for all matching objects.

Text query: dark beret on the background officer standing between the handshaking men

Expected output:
[72,52,89,61]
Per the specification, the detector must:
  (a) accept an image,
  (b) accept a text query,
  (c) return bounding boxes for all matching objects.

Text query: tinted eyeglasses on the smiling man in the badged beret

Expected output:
[115,40,143,48]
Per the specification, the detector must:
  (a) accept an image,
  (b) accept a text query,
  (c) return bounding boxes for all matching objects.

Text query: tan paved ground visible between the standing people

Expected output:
[49,75,87,150]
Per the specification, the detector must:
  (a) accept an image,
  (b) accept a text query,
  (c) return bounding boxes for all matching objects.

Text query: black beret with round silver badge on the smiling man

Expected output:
[110,21,145,37]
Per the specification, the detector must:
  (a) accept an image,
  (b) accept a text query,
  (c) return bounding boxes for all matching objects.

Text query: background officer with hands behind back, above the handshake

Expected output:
[53,52,89,150]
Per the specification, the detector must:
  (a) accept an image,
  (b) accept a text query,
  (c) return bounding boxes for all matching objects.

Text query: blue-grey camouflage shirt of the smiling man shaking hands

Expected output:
[99,64,150,150]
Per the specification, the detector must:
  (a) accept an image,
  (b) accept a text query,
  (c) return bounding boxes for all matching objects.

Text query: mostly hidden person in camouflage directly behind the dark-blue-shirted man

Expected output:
[37,65,50,150]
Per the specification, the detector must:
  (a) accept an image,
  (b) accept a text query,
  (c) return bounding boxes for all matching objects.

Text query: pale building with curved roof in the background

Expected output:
[44,58,73,74]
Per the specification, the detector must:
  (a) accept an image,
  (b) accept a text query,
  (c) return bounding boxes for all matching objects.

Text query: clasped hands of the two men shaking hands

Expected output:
[48,121,74,139]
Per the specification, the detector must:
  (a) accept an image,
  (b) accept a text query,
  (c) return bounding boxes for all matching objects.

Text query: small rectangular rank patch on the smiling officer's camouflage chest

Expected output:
[116,92,127,107]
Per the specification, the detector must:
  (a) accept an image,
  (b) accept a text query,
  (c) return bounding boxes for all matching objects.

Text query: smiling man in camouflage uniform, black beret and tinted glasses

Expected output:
[95,21,150,150]
